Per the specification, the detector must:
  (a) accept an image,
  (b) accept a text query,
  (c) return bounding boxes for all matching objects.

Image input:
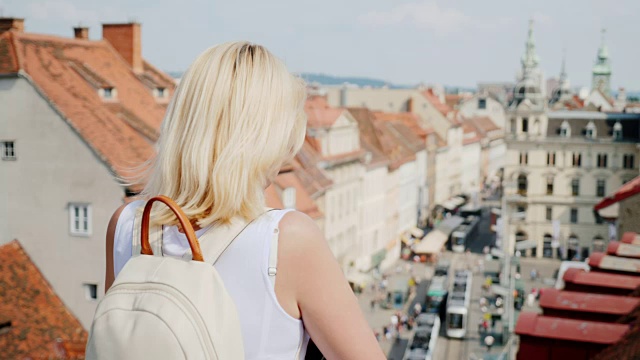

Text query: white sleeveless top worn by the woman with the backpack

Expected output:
[113,200,309,360]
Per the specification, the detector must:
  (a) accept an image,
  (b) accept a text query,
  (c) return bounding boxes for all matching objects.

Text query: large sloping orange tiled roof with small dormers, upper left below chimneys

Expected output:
[0,27,175,186]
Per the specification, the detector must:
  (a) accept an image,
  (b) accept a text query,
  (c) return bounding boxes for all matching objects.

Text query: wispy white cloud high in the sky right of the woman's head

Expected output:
[358,0,472,34]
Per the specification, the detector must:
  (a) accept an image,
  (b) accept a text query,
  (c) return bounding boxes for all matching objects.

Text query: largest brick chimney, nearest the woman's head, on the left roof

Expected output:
[102,23,143,73]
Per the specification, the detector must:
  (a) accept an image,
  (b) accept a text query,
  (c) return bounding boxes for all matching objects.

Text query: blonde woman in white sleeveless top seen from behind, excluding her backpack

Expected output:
[106,42,384,360]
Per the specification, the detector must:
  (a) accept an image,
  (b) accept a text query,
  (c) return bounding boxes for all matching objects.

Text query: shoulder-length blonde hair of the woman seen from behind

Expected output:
[141,42,306,227]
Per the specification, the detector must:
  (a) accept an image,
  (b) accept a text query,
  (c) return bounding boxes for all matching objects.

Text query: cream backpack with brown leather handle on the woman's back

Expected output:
[86,196,255,360]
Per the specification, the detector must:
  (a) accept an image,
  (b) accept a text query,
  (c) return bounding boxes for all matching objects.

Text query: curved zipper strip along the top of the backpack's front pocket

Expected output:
[108,283,218,359]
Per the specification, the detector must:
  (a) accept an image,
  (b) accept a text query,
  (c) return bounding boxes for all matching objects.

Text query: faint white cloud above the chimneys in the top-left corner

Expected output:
[29,0,101,23]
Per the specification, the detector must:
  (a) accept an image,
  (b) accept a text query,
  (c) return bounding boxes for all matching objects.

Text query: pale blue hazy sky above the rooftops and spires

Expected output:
[5,0,640,90]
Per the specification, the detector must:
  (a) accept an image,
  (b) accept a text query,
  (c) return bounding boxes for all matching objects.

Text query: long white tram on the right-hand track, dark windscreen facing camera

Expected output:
[445,270,473,339]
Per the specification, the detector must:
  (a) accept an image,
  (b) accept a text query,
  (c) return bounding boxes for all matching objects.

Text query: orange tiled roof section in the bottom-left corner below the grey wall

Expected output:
[0,240,87,359]
